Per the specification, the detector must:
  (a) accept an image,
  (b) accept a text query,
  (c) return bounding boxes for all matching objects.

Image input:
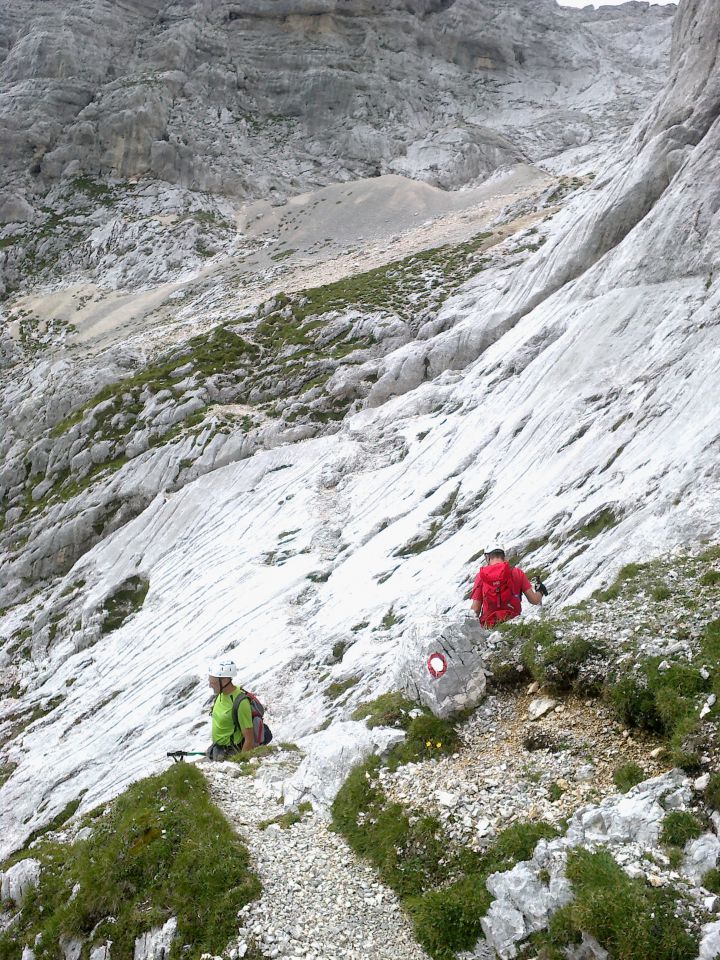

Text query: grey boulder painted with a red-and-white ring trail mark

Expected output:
[398,617,487,718]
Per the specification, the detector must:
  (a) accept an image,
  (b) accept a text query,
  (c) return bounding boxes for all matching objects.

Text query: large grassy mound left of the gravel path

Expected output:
[0,763,260,960]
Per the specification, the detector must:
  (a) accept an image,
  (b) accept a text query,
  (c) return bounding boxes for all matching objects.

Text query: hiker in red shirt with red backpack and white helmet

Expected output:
[472,541,547,629]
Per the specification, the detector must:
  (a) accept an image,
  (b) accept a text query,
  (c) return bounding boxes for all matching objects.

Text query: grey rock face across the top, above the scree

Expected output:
[0,0,673,199]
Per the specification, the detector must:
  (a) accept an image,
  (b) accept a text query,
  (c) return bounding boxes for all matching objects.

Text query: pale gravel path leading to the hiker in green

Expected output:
[203,754,427,960]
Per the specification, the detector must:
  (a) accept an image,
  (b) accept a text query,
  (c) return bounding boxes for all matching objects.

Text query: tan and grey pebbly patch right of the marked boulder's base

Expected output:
[380,690,670,849]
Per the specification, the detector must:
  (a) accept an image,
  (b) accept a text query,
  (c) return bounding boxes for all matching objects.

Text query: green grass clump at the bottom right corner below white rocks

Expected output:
[546,849,698,960]
